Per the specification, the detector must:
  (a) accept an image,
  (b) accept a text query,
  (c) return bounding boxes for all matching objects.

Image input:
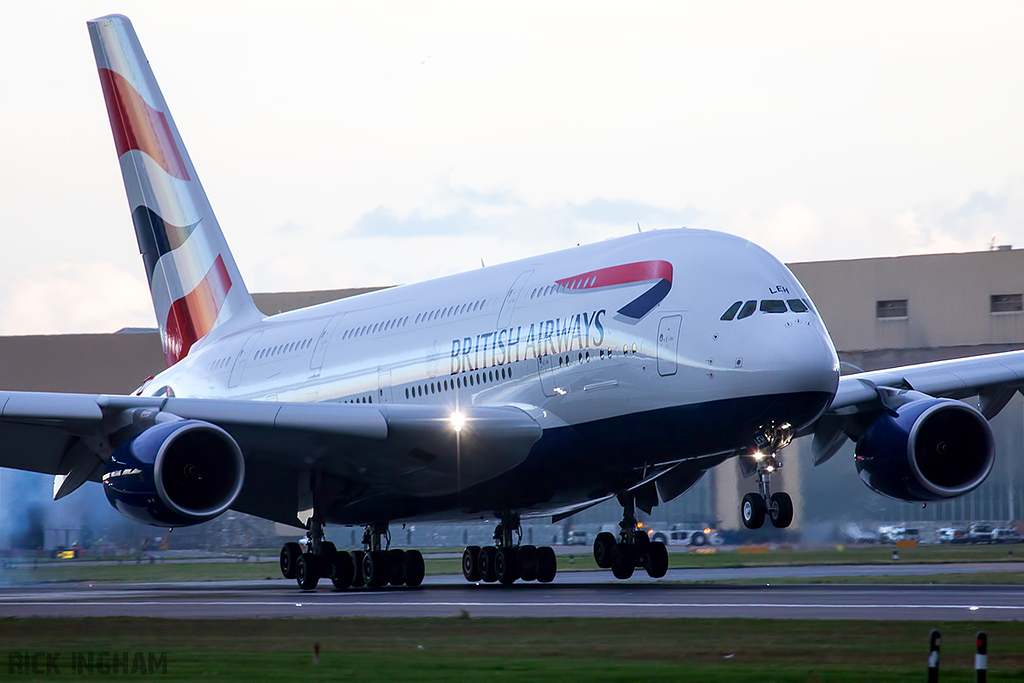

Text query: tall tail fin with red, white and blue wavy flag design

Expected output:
[88,14,263,367]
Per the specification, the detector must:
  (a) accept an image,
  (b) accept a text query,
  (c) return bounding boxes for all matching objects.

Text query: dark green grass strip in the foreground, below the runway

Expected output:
[0,617,1024,683]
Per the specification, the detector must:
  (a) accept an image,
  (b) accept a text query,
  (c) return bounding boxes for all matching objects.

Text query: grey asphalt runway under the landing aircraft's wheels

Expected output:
[6,563,1024,621]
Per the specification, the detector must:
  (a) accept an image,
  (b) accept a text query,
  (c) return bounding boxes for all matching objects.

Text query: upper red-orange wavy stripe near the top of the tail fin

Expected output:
[99,69,190,180]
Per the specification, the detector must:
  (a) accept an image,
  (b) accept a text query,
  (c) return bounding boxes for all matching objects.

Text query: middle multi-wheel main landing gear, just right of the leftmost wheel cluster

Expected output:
[462,512,558,586]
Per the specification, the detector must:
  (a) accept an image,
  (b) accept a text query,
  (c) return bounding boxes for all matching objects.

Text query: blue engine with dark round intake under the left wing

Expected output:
[103,420,245,526]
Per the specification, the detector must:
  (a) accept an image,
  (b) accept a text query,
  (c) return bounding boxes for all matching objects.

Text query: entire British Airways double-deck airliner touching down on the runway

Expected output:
[0,15,1024,589]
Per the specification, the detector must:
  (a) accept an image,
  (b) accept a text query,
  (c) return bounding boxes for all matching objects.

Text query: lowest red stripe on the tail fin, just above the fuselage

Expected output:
[164,256,231,368]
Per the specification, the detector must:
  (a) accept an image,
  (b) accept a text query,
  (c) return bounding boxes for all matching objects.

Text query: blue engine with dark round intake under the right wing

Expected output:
[856,398,995,503]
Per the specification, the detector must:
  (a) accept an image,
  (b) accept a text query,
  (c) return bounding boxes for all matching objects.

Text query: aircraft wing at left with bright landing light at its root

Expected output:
[0,392,542,523]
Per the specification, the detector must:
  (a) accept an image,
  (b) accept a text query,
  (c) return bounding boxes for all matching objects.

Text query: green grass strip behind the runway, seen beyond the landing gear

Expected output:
[0,546,1024,584]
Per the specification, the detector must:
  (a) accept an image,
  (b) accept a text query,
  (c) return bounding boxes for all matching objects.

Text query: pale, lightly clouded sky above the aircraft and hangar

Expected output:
[0,0,1024,335]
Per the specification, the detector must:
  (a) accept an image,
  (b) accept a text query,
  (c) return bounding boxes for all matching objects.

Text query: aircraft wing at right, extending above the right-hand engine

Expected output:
[812,351,1024,465]
